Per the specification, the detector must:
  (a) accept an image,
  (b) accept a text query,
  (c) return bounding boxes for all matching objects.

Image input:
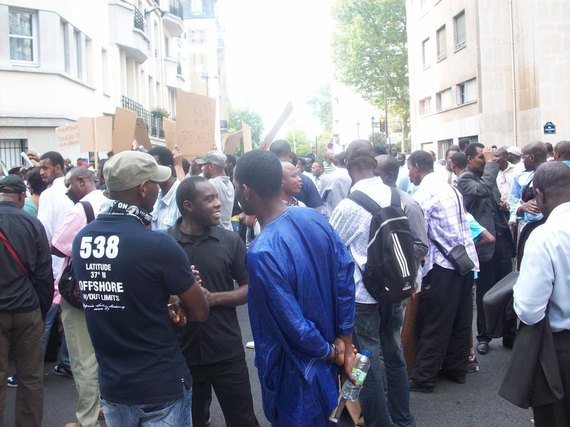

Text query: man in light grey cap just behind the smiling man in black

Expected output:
[196,151,234,231]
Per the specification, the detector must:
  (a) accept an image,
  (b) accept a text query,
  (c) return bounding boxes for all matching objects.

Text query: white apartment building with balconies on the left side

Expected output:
[0,0,189,167]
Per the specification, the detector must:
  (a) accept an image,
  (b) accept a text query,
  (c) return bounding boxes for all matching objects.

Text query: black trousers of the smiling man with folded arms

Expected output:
[190,354,259,427]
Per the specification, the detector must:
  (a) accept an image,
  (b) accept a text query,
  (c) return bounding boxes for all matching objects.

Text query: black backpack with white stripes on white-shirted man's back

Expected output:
[348,188,417,303]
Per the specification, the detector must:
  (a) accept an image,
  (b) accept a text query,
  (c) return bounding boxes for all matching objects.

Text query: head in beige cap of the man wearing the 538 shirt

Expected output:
[103,151,172,212]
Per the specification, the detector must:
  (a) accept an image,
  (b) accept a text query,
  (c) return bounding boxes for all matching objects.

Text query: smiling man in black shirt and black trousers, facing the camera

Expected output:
[168,176,259,427]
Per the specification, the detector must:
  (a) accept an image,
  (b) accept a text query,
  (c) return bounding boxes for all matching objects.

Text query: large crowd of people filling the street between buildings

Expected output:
[0,140,570,427]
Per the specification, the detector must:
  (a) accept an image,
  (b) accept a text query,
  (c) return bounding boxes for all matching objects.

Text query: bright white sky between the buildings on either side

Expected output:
[218,0,333,134]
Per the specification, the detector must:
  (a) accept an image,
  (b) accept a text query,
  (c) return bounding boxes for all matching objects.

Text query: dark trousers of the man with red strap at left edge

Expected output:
[0,308,44,427]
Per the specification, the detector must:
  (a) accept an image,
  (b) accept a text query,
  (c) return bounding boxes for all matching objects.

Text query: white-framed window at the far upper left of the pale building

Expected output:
[8,10,37,63]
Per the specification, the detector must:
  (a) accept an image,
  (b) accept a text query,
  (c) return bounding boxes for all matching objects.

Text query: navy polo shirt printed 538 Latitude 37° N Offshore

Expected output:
[72,214,194,405]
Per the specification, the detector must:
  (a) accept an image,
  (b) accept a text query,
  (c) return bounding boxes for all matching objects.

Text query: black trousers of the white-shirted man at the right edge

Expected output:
[532,331,570,427]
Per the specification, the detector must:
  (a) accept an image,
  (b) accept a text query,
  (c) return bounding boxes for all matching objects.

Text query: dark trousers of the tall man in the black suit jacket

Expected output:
[475,235,517,346]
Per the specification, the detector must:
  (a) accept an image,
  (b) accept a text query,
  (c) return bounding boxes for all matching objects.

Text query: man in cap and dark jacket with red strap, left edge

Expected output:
[0,175,53,427]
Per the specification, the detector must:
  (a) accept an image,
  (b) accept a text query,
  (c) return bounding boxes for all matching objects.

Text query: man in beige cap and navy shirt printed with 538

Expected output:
[72,151,208,426]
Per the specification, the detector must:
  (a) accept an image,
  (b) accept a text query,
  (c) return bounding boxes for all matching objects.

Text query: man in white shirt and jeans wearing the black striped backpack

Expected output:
[330,140,414,425]
